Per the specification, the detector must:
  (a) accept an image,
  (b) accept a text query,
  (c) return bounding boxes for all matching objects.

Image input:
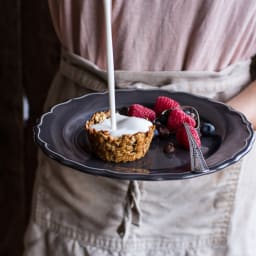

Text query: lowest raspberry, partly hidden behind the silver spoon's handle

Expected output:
[176,126,201,150]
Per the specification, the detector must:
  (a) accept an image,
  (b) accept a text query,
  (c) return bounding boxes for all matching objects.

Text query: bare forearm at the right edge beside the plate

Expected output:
[227,81,256,130]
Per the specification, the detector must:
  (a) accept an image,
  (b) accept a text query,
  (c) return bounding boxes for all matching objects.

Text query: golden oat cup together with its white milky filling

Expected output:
[85,111,155,163]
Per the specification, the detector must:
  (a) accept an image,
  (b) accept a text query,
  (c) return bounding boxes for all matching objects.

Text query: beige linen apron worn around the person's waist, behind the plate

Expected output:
[24,51,256,256]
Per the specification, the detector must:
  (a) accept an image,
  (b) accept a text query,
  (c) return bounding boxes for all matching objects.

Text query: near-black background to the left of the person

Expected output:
[0,0,60,256]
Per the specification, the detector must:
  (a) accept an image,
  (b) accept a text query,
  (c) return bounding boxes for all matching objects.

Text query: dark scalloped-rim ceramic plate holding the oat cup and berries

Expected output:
[34,90,254,180]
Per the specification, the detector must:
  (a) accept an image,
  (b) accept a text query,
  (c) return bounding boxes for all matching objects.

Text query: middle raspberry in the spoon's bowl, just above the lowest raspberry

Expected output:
[167,108,196,131]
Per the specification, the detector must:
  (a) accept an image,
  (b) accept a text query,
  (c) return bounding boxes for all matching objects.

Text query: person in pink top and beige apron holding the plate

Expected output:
[24,0,256,256]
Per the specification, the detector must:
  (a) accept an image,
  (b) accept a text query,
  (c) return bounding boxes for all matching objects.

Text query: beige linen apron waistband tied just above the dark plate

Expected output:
[60,49,251,102]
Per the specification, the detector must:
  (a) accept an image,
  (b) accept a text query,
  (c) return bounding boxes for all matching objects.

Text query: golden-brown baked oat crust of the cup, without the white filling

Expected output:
[85,111,155,163]
